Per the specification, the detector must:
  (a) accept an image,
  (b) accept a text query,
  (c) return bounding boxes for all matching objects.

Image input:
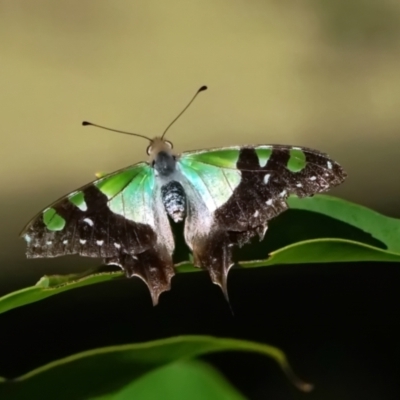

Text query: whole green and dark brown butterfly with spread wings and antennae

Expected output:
[21,86,346,305]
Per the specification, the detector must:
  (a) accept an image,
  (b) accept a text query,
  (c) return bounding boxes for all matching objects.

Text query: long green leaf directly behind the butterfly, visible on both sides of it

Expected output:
[0,195,400,313]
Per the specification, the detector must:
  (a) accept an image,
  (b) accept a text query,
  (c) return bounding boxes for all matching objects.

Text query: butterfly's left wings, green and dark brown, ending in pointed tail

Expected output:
[22,163,174,303]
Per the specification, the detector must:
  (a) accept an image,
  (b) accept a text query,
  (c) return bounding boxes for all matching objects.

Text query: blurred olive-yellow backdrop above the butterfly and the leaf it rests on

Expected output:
[0,0,400,286]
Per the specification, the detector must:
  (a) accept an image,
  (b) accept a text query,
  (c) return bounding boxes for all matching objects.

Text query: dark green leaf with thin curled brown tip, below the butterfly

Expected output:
[0,336,312,400]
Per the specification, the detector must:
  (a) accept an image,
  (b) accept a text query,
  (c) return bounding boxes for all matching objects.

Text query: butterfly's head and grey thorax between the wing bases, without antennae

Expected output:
[147,137,176,177]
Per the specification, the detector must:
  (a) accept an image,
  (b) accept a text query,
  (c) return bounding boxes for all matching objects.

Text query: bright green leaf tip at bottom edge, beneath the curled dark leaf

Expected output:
[92,360,244,400]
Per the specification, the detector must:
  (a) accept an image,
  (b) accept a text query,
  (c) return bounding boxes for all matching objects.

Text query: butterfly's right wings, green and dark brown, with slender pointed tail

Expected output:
[179,145,346,294]
